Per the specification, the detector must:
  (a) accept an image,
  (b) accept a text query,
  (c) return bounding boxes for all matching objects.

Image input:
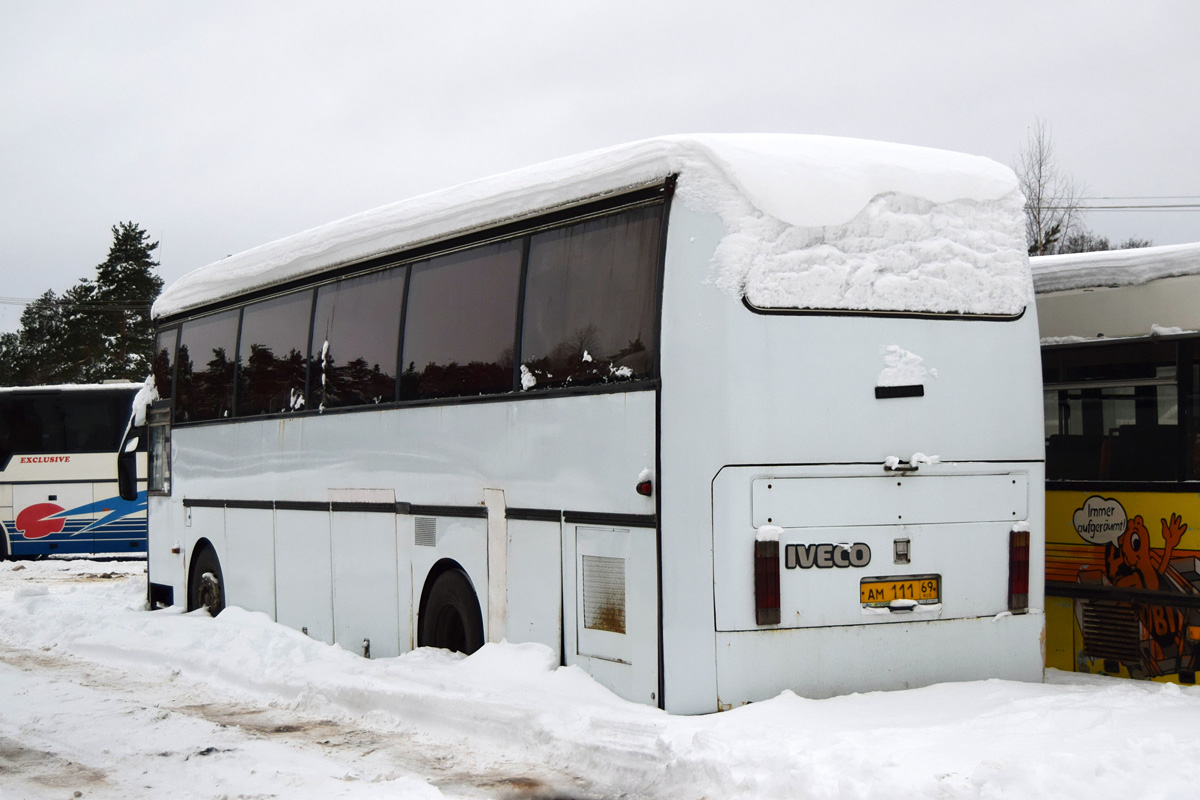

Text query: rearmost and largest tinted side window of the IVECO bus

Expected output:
[521,206,662,389]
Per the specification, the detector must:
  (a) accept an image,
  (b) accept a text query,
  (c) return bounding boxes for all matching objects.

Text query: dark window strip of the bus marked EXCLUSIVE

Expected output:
[0,390,136,457]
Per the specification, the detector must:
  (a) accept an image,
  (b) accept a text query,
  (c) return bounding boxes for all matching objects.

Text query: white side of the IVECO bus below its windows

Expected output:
[149,391,659,703]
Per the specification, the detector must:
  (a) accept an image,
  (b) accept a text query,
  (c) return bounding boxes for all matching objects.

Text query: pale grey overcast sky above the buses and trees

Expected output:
[0,0,1200,330]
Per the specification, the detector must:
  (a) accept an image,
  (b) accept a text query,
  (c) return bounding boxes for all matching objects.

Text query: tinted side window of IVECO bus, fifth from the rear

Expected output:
[175,309,240,422]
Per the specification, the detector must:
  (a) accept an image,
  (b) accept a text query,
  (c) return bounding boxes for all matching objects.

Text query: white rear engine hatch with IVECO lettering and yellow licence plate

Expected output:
[713,464,1042,631]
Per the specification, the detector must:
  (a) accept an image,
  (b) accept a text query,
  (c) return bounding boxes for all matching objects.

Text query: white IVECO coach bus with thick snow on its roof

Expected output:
[117,134,1044,712]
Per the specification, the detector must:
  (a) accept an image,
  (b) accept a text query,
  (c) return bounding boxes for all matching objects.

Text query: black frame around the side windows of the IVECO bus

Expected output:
[155,182,674,427]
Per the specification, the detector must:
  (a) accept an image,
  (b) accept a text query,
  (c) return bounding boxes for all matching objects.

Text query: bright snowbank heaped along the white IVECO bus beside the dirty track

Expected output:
[0,560,1200,800]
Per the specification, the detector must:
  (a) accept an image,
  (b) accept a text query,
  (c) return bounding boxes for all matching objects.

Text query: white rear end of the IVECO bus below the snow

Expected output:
[660,203,1044,712]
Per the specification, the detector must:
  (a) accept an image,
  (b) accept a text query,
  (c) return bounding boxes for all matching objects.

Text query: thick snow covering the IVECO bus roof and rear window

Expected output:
[152,134,1032,318]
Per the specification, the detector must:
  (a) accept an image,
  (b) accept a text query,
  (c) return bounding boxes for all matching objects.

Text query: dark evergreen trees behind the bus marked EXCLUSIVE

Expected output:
[0,222,162,386]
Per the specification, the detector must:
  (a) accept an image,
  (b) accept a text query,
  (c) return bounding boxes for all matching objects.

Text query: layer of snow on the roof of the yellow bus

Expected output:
[1030,242,1200,294]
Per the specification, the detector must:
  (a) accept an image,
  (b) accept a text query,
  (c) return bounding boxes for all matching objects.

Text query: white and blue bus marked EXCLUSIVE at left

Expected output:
[0,383,146,558]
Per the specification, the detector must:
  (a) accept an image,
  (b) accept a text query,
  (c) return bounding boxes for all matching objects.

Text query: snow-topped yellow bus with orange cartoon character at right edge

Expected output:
[1031,243,1200,684]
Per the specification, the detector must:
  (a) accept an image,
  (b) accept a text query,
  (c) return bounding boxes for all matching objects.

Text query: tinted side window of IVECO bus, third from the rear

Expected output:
[310,267,406,408]
